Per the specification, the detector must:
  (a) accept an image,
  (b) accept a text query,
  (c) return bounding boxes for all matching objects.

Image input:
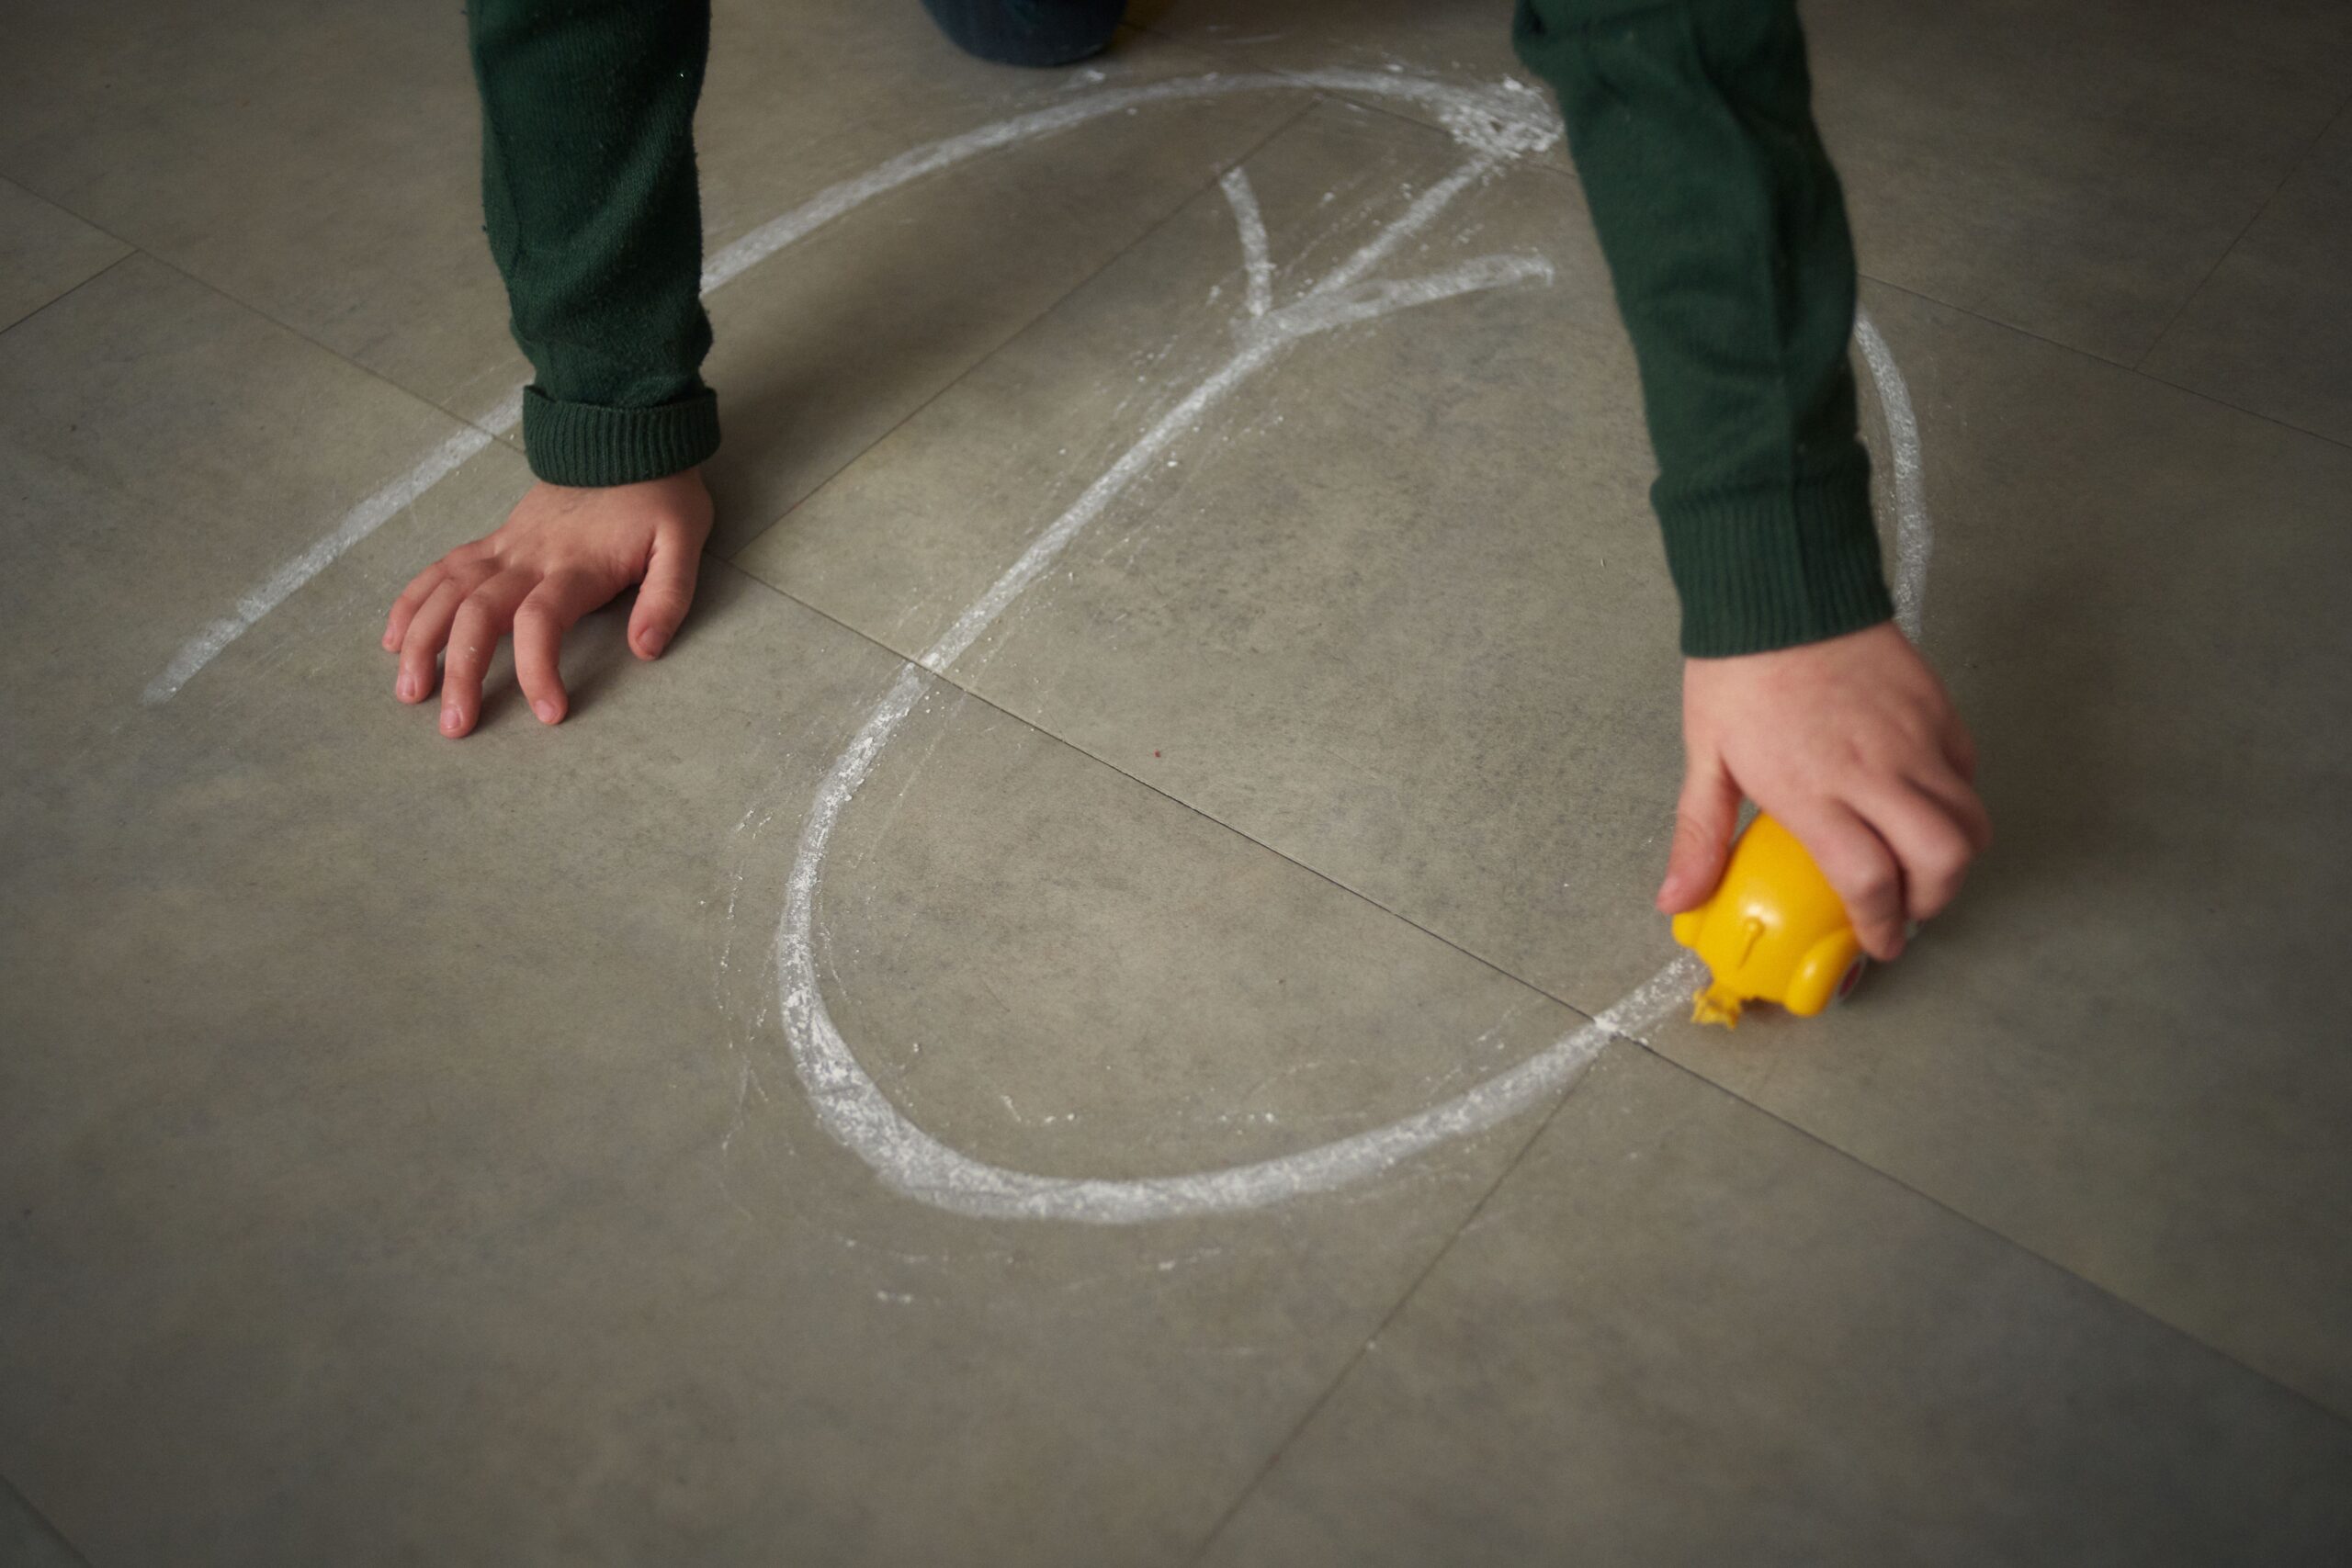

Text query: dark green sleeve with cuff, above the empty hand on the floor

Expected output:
[468,0,719,484]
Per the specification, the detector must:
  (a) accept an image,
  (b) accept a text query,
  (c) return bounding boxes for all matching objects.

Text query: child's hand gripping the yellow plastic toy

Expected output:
[1658,626,1992,959]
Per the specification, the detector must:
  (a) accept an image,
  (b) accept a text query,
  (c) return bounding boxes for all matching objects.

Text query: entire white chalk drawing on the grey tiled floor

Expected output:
[143,71,1933,1224]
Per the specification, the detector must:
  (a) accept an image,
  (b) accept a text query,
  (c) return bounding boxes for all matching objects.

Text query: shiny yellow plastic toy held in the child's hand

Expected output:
[1675,816,1865,1030]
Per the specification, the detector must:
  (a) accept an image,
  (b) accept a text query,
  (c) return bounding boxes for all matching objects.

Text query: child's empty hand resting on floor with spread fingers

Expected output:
[383,468,710,736]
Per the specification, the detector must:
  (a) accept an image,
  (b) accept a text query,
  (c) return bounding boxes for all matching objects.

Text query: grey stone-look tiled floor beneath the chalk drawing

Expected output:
[0,0,2352,1565]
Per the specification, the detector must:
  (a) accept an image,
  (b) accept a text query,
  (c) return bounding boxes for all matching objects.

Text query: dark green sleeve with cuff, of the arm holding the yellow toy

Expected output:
[1517,0,1894,659]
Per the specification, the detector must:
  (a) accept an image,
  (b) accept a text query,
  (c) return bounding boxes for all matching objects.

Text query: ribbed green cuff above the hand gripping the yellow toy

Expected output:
[1654,463,1895,659]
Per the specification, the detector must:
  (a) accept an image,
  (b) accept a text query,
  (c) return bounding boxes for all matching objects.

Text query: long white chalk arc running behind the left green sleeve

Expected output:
[141,71,1557,705]
